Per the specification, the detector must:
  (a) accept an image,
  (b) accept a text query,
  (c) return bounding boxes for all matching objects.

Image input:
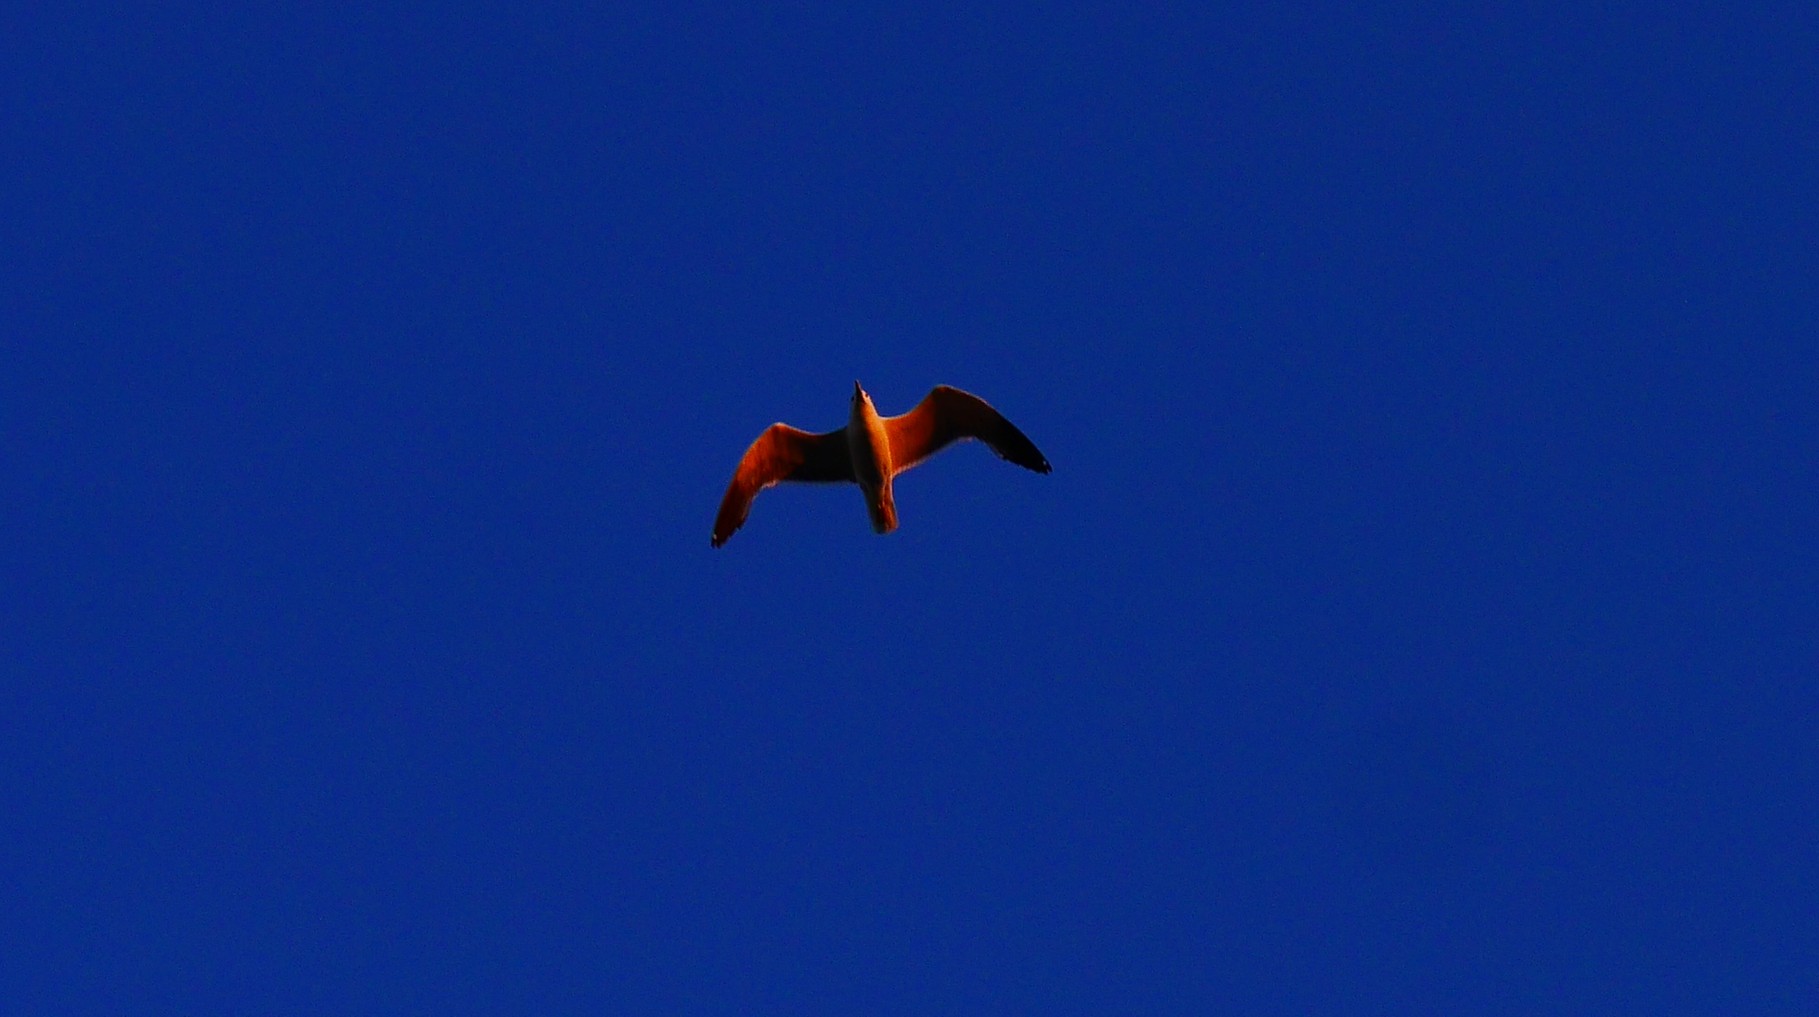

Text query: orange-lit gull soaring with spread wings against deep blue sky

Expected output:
[713,382,1050,548]
